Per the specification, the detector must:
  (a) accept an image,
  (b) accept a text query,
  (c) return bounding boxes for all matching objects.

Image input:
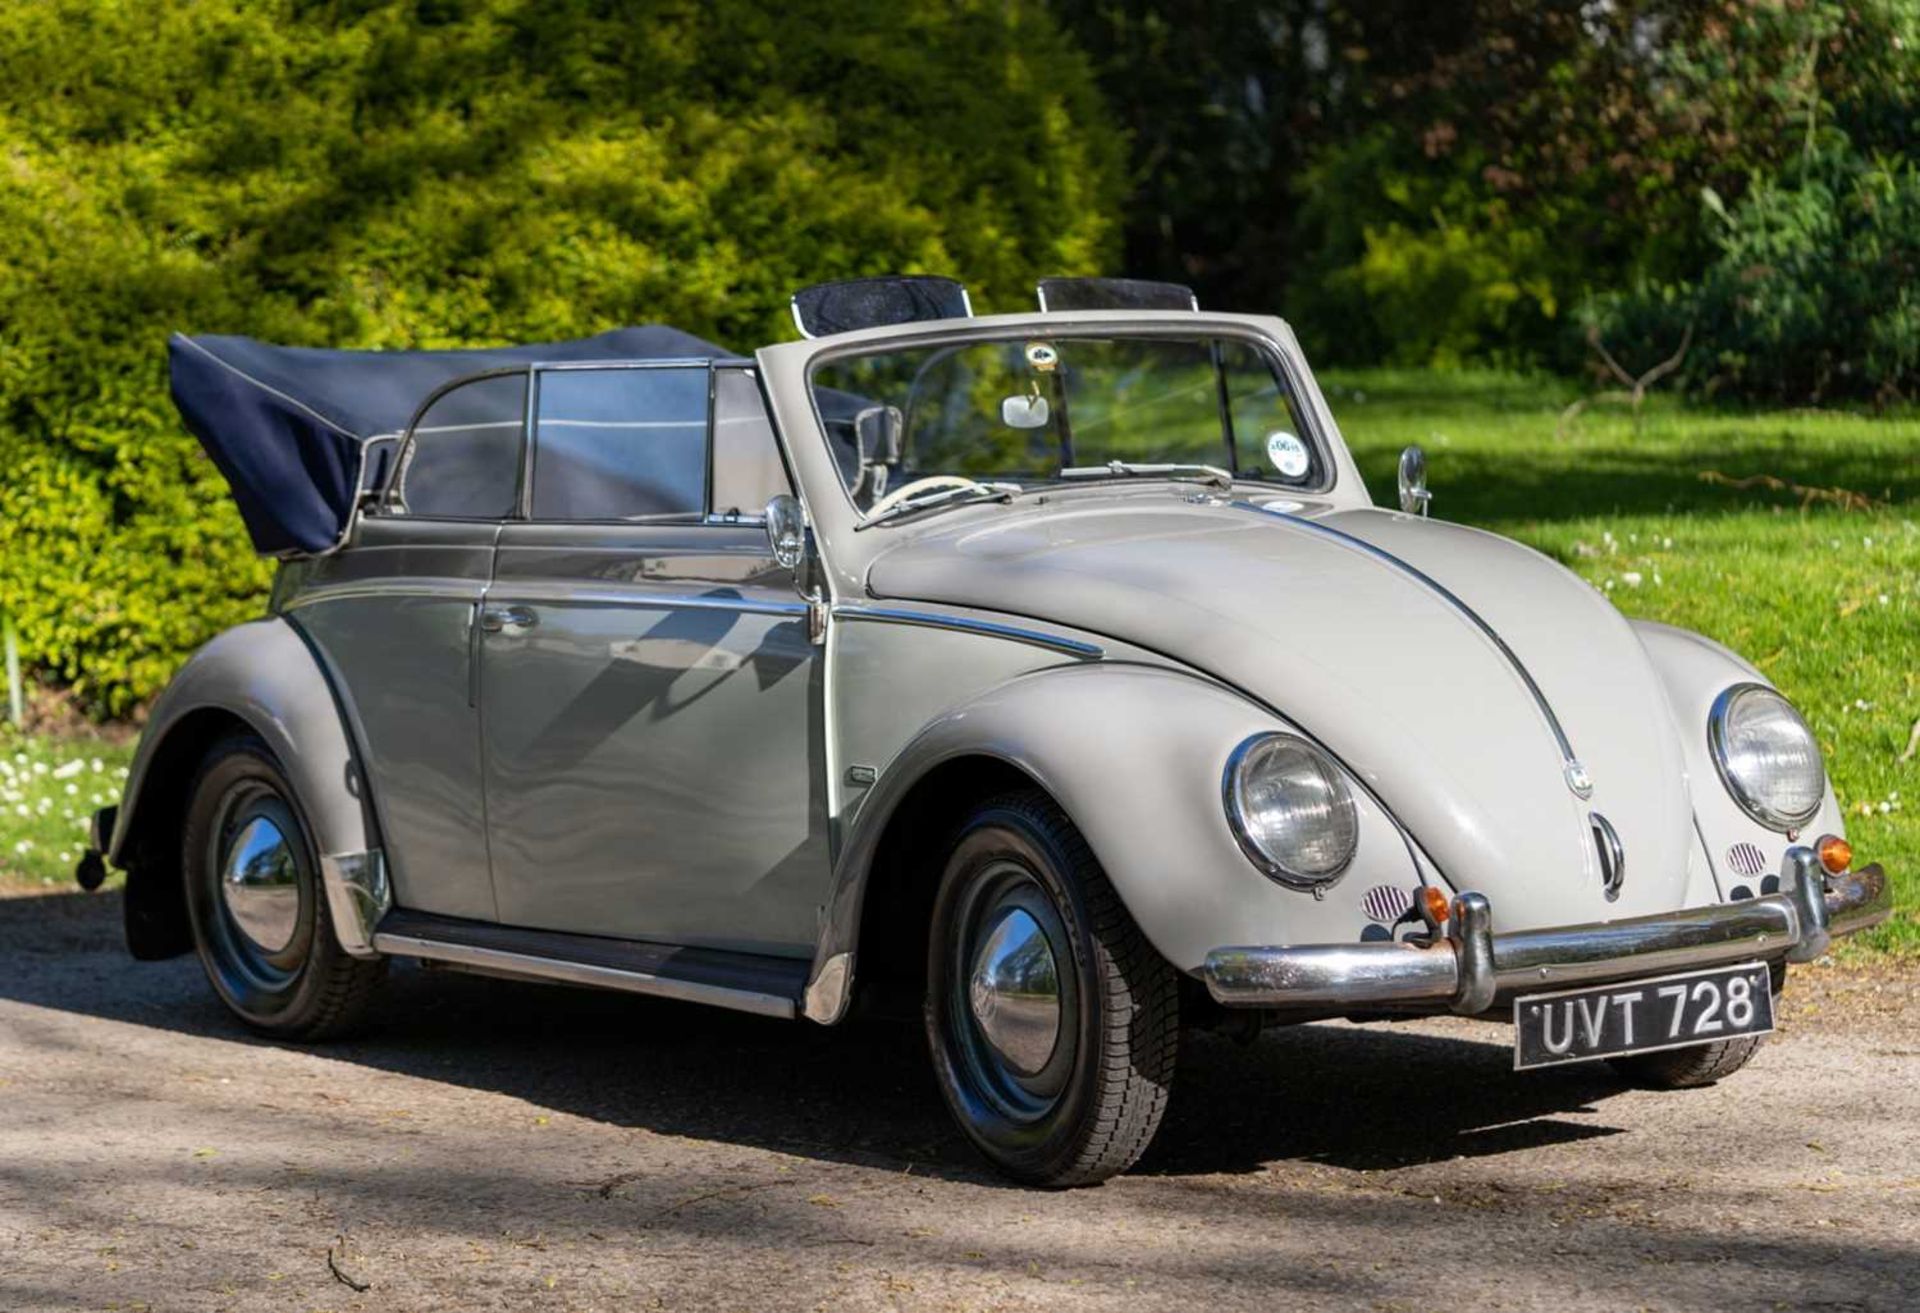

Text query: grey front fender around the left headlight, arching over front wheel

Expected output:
[808,662,1421,1021]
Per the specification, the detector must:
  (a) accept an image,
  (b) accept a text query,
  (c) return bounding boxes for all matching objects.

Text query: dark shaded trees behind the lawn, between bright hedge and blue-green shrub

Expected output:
[1062,0,1920,374]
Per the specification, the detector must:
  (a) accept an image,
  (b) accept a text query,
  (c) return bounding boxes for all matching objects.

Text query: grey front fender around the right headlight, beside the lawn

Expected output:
[1632,620,1847,902]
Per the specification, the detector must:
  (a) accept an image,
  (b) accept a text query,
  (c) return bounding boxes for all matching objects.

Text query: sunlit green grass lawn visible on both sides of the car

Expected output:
[0,370,1920,954]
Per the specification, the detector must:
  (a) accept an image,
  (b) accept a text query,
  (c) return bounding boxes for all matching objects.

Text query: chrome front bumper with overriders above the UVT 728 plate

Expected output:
[1200,845,1893,1015]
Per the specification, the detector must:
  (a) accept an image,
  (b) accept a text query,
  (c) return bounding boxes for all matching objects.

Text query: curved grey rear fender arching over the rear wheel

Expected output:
[108,616,390,956]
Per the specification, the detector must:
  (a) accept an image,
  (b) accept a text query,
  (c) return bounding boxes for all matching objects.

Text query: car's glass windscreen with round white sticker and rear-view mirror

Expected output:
[812,334,1325,511]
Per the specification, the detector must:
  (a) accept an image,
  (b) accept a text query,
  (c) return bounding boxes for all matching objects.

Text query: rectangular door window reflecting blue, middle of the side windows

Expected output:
[534,365,708,520]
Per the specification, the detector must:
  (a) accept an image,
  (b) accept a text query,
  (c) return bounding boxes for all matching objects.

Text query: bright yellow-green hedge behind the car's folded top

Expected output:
[0,0,1123,714]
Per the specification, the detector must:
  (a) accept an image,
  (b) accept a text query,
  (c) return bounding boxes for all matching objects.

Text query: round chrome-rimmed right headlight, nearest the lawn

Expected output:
[1707,683,1826,831]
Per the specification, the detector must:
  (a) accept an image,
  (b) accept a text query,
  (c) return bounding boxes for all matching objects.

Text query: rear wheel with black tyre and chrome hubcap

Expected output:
[180,735,386,1038]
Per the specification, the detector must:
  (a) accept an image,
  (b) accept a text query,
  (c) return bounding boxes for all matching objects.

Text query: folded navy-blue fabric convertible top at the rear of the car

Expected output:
[167,324,733,557]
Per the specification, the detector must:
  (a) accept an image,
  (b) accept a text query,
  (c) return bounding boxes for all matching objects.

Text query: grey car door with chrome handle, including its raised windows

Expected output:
[480,363,828,956]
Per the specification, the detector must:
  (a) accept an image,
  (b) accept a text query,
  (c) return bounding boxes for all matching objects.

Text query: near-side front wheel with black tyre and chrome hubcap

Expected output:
[925,793,1179,1186]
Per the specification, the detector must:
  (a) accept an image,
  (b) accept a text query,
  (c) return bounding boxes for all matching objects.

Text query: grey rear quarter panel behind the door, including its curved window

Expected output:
[276,369,528,919]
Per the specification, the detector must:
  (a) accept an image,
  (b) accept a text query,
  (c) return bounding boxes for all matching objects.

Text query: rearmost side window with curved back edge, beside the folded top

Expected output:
[386,372,526,520]
